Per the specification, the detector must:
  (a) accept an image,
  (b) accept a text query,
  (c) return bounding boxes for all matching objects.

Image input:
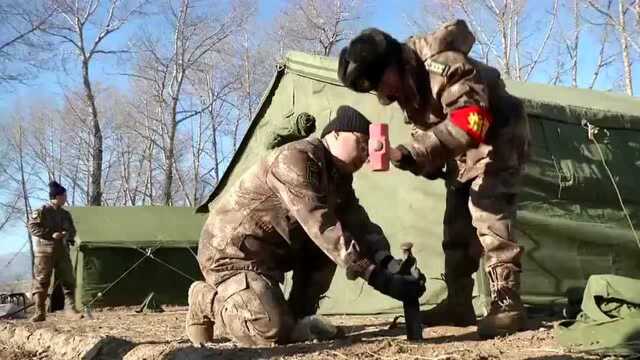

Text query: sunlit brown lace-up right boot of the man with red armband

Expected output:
[478,264,527,339]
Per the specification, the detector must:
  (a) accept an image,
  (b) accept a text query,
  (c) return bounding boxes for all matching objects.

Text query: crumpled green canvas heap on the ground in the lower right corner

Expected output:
[555,275,640,354]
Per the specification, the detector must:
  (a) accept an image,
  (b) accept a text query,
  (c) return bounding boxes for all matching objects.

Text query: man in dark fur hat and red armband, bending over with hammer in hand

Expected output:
[338,20,529,338]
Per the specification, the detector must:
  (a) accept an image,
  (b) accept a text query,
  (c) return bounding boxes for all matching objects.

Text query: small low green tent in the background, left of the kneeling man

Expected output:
[70,206,205,306]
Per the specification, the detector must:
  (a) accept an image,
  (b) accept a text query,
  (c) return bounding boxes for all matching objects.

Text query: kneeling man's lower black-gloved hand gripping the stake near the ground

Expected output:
[368,266,426,301]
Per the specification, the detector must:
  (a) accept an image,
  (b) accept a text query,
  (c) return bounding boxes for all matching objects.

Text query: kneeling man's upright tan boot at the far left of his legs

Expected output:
[185,281,216,347]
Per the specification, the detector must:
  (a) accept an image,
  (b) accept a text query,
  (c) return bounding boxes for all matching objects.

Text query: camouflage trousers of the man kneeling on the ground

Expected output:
[189,239,336,346]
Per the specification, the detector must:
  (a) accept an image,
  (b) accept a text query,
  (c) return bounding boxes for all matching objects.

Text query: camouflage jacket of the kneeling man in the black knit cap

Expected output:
[198,138,389,284]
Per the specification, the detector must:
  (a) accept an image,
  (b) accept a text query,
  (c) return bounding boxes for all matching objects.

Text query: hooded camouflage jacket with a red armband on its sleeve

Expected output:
[405,20,529,182]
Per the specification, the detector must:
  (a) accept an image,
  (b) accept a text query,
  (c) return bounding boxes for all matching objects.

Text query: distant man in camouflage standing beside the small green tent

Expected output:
[28,181,78,322]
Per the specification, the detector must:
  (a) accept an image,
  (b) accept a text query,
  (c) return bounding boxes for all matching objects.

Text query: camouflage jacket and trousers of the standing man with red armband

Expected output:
[406,21,529,287]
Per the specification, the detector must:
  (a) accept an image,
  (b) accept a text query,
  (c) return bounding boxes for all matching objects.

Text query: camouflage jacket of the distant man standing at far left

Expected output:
[27,204,76,253]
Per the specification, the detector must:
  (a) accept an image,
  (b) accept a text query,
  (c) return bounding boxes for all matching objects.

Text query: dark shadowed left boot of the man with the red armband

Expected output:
[420,275,476,327]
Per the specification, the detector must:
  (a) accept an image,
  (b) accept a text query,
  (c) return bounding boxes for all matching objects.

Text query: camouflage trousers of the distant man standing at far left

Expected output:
[32,239,75,297]
